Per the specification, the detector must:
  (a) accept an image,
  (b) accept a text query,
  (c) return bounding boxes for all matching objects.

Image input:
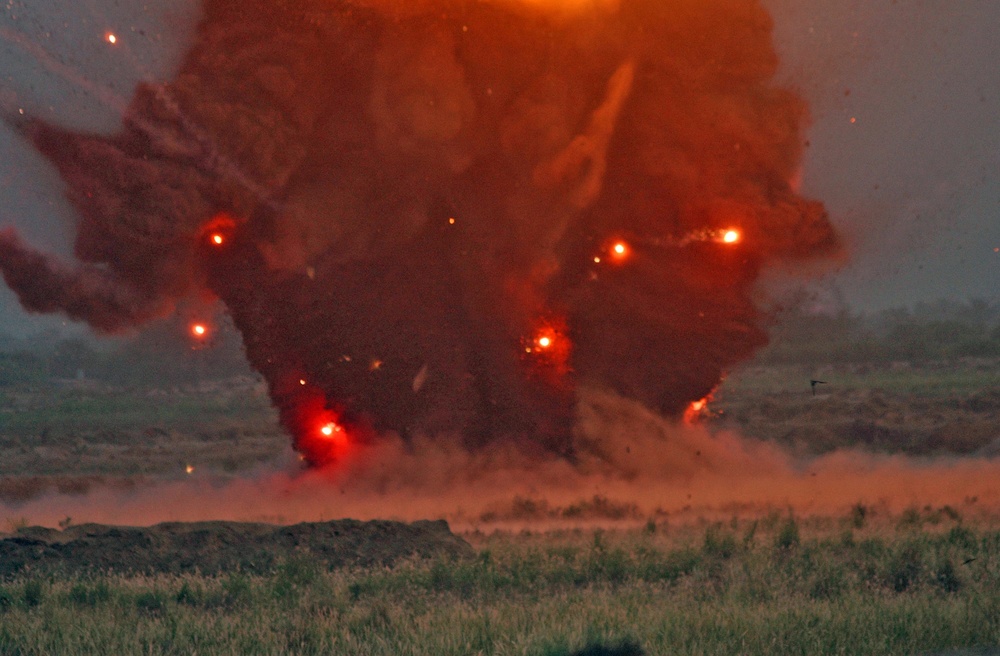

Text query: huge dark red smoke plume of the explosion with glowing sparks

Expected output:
[0,0,838,464]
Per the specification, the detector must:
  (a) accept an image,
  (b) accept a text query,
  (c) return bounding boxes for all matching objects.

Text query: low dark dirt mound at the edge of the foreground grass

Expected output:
[0,519,472,578]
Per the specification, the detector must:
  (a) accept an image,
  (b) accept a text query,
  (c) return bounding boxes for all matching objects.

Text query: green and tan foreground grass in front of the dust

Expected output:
[0,507,1000,656]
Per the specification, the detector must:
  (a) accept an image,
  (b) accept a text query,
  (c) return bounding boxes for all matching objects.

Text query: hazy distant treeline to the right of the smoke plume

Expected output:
[761,299,1000,363]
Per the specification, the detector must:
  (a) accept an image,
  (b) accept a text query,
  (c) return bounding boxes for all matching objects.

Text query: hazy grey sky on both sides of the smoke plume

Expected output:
[0,0,1000,332]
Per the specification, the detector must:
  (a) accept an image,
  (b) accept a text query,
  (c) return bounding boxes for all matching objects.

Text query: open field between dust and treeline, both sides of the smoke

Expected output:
[0,359,1000,502]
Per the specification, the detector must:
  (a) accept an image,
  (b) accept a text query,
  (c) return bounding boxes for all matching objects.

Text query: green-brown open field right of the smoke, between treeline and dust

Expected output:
[709,358,1000,456]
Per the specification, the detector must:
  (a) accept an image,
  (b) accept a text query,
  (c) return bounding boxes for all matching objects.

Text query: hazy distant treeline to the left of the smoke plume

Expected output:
[0,320,252,386]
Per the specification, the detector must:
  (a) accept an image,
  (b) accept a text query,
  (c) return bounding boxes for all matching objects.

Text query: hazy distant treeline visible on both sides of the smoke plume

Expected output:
[0,299,1000,386]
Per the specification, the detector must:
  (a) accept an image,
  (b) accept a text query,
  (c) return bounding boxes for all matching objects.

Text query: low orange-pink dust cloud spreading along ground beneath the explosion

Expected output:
[0,390,1000,531]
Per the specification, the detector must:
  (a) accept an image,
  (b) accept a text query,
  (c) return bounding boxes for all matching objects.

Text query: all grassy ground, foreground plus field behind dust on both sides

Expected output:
[0,352,1000,656]
